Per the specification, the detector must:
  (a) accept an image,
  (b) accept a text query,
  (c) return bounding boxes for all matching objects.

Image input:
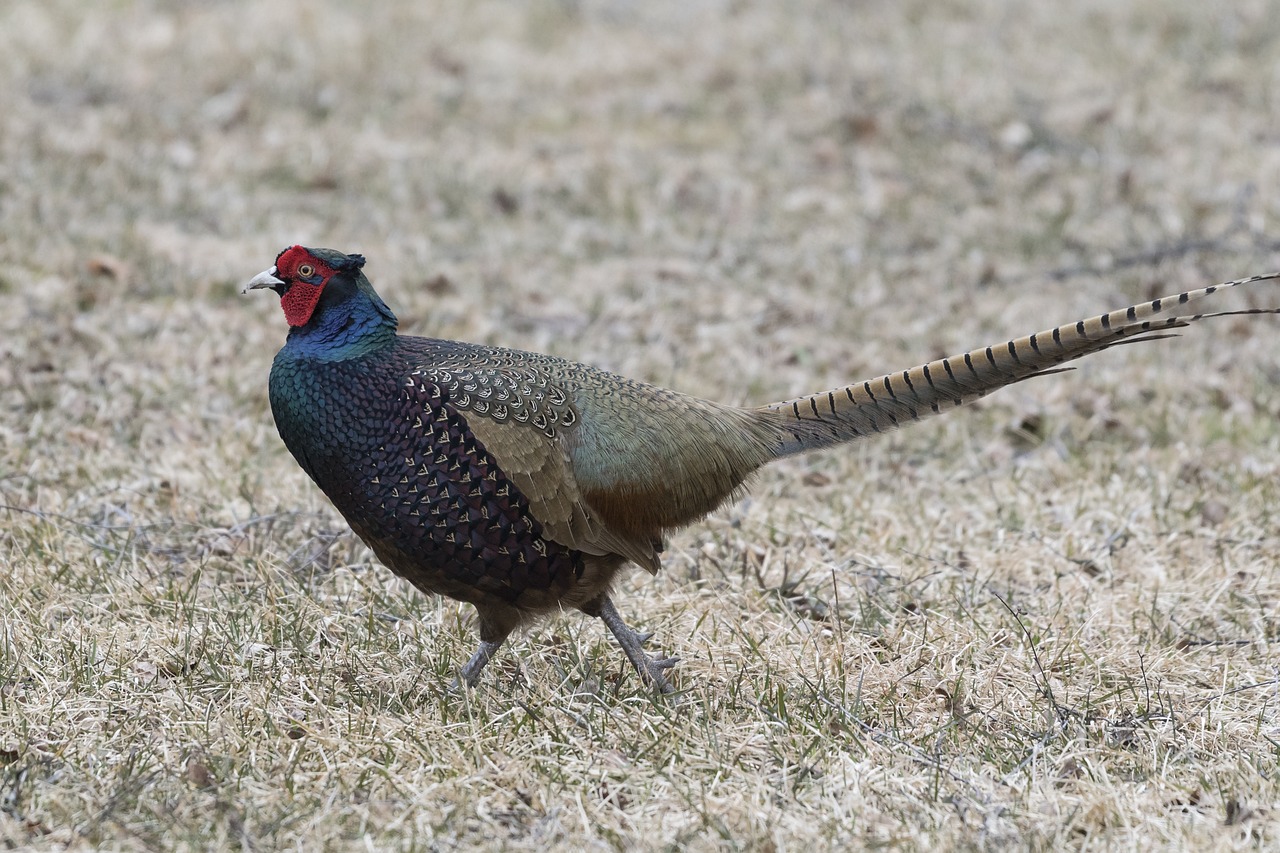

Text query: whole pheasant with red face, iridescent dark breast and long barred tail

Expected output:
[244,246,1280,693]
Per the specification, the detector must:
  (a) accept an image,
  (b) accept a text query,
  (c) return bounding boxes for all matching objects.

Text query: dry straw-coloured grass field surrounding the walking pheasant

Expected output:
[0,0,1280,850]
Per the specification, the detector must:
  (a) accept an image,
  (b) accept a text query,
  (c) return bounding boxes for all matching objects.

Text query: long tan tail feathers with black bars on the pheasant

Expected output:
[753,273,1280,456]
